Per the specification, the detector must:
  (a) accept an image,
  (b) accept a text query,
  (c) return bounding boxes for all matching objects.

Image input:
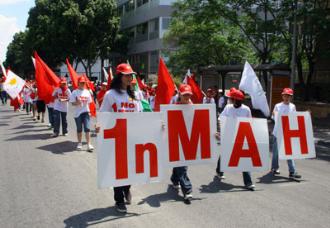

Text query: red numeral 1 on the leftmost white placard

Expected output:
[104,119,128,179]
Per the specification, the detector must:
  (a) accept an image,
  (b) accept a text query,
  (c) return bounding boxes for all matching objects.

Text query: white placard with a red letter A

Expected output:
[220,117,270,172]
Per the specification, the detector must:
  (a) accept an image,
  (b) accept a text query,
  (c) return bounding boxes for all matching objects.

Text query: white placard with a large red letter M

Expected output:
[160,104,220,167]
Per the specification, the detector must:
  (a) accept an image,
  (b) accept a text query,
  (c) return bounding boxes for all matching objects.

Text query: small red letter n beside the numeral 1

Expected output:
[135,143,158,177]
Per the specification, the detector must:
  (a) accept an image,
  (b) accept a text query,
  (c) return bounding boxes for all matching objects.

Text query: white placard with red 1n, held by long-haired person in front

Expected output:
[97,112,166,188]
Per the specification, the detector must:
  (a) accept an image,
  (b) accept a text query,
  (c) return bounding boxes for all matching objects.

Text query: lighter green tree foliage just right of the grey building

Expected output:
[164,0,253,75]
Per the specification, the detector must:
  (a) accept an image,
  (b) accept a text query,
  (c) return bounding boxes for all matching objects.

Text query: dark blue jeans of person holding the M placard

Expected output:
[171,166,192,195]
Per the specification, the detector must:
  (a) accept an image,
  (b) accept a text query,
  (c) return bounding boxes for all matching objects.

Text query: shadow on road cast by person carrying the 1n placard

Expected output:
[63,207,143,228]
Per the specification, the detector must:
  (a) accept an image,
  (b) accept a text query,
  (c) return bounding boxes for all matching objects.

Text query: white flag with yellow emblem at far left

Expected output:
[3,70,25,99]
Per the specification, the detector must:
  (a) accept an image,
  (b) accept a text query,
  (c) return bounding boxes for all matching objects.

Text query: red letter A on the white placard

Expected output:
[228,122,261,167]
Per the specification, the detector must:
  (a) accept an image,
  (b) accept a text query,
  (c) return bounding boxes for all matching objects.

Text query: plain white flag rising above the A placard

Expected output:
[239,61,270,117]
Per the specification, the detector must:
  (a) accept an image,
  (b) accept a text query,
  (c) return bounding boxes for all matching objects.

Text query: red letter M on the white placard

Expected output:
[168,110,211,162]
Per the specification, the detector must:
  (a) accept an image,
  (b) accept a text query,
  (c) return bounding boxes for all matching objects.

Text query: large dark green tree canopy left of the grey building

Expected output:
[27,0,119,75]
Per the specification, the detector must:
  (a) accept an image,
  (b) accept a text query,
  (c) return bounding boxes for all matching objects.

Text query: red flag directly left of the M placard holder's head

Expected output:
[155,58,175,111]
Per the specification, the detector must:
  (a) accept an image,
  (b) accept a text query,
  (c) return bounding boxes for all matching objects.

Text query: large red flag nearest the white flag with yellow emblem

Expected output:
[34,52,60,104]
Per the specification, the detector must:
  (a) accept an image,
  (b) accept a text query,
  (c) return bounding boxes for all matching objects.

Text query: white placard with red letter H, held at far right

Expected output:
[275,112,316,160]
